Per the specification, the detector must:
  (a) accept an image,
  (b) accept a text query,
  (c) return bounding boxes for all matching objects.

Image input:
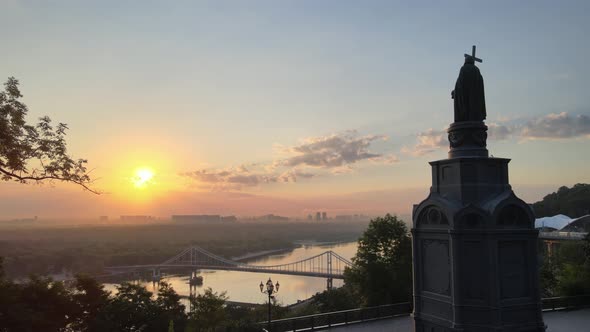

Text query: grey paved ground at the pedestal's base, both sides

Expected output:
[326,308,590,332]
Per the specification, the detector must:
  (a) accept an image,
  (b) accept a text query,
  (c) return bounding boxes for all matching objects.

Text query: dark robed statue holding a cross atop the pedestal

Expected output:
[451,46,486,122]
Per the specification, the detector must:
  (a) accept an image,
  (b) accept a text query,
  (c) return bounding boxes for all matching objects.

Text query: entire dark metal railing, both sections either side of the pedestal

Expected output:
[260,294,590,332]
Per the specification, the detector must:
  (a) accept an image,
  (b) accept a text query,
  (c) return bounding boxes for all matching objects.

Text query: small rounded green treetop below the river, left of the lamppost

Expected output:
[189,287,228,331]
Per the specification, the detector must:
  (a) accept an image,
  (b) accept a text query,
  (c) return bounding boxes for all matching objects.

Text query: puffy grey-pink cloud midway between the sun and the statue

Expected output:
[276,131,387,169]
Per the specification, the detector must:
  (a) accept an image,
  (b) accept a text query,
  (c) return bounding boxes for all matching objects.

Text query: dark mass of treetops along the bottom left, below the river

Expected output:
[0,252,287,332]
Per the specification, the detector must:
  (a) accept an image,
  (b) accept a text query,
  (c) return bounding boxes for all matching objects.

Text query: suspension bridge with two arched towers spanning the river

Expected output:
[105,246,352,279]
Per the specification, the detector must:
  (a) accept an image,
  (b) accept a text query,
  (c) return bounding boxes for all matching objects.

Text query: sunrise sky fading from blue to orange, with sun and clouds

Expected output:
[0,0,590,219]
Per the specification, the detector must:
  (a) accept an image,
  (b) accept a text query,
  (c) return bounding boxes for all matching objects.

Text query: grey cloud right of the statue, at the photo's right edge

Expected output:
[520,112,590,139]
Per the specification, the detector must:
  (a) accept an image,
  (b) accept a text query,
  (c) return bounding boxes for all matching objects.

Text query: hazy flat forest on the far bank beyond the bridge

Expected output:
[0,222,367,278]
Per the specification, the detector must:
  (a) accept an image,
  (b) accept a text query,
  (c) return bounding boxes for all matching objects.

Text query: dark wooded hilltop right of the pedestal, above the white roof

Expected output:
[533,183,590,218]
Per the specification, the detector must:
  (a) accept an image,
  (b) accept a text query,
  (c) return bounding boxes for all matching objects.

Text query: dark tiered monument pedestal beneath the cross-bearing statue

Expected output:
[412,121,545,332]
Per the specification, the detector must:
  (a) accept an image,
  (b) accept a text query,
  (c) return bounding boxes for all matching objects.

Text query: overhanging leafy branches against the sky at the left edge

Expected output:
[0,77,98,193]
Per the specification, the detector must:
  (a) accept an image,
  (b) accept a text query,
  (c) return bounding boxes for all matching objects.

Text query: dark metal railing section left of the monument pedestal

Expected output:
[260,302,412,332]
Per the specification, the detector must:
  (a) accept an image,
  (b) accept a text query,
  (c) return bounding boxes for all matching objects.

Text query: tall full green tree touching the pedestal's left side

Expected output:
[344,214,412,306]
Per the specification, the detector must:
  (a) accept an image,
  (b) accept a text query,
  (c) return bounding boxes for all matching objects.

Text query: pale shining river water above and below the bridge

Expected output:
[104,242,357,305]
